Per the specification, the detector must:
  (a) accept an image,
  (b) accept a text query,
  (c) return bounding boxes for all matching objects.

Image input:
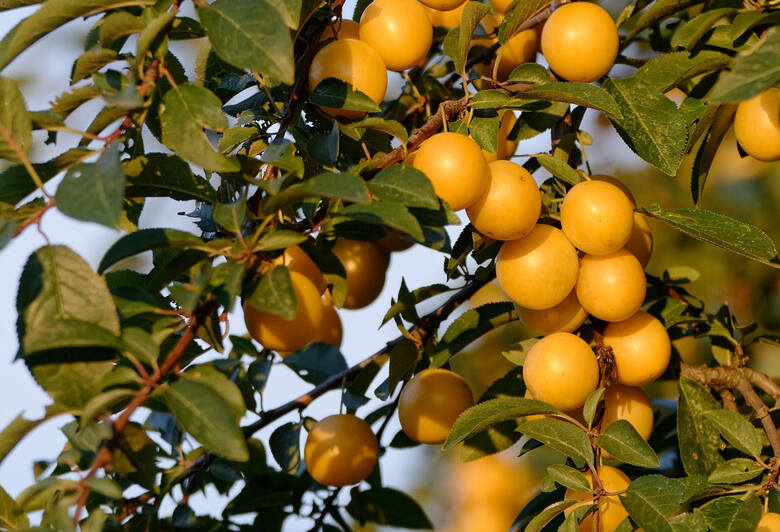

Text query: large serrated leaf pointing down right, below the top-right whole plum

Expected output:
[604,78,688,175]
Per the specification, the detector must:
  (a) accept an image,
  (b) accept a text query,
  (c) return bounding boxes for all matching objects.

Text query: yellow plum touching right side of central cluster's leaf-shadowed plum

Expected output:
[567,251,646,321]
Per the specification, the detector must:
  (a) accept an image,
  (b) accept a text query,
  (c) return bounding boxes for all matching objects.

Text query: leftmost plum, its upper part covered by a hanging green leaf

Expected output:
[244,271,322,352]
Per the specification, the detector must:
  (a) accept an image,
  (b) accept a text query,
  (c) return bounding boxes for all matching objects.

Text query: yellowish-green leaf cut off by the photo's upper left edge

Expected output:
[0,76,32,162]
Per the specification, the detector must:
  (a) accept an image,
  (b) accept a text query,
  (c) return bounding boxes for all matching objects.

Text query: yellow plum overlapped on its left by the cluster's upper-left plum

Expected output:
[466,160,542,240]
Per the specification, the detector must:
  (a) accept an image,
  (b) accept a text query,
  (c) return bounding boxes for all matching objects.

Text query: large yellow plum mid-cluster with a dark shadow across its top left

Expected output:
[496,224,579,310]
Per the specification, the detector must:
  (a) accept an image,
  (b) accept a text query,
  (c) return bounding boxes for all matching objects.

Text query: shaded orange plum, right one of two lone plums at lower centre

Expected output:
[398,369,474,444]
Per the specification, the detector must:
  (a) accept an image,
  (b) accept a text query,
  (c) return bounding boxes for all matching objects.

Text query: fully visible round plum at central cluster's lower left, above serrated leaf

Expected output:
[523,333,599,410]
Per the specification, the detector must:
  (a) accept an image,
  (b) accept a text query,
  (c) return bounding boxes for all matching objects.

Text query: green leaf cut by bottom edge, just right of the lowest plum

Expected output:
[620,475,683,532]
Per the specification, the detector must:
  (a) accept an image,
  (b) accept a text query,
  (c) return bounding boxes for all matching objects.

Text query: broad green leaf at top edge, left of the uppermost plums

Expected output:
[198,0,295,84]
